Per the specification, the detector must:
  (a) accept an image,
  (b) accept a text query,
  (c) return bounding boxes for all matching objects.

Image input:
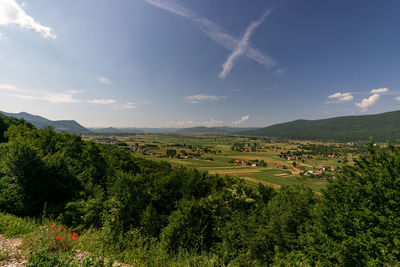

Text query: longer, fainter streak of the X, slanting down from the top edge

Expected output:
[146,0,277,77]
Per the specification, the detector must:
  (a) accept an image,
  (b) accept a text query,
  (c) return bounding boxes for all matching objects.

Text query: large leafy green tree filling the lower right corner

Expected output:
[302,143,400,266]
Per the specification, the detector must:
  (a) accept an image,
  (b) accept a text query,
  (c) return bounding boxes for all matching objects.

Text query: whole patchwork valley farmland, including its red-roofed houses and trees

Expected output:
[86,134,363,192]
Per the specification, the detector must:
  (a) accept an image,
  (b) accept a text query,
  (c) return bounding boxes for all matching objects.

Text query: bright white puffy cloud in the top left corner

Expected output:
[0,0,56,38]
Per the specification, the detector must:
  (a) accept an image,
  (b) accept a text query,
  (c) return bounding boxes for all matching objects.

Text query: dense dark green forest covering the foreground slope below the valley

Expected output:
[0,115,400,266]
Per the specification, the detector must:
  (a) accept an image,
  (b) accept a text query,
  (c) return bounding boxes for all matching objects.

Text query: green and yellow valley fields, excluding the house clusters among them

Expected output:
[87,134,360,192]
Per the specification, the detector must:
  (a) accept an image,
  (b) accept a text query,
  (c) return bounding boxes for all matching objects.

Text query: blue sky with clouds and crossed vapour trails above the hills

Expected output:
[0,0,400,127]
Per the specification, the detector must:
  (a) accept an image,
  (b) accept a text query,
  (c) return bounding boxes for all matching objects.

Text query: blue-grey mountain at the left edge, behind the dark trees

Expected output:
[0,111,91,134]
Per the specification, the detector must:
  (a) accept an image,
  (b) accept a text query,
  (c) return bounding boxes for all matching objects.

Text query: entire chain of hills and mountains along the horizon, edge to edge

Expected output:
[0,111,400,141]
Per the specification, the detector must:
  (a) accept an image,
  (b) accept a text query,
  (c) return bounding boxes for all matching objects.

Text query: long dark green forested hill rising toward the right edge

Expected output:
[240,111,400,141]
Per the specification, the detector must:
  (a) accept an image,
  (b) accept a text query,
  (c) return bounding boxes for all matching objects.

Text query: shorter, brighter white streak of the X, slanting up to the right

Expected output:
[219,10,271,79]
